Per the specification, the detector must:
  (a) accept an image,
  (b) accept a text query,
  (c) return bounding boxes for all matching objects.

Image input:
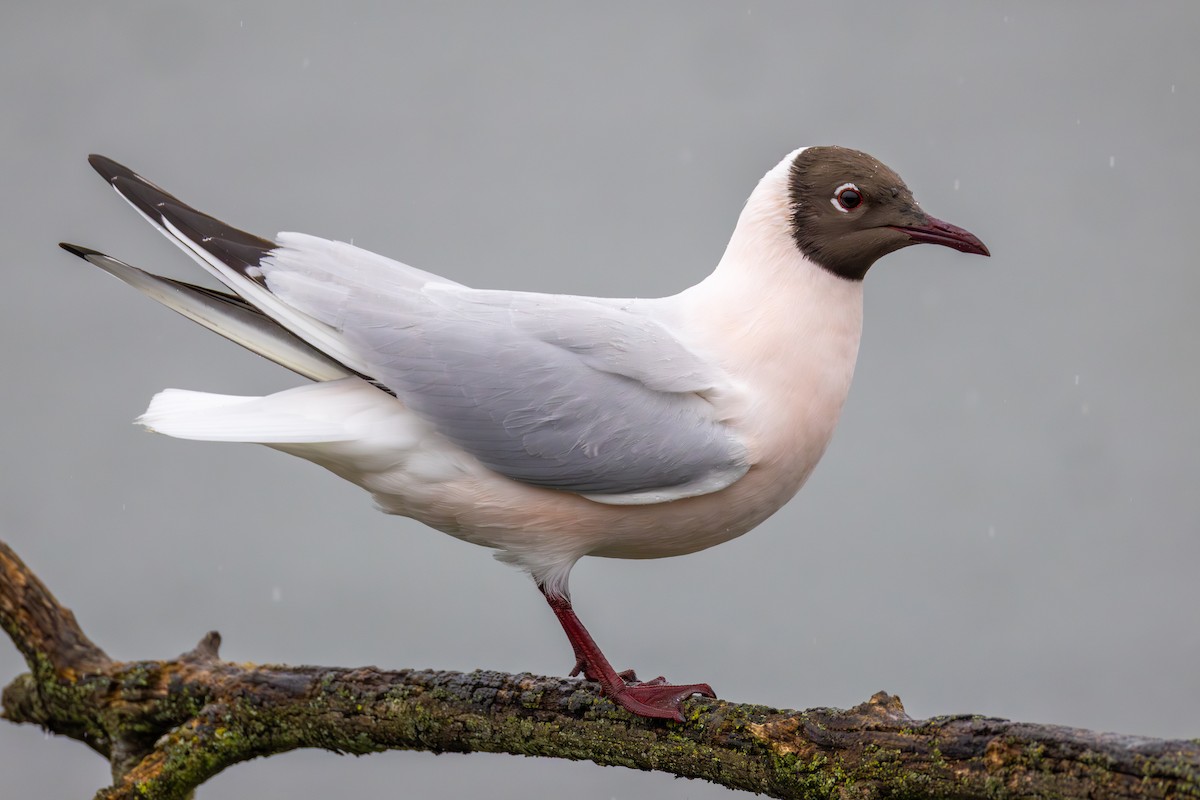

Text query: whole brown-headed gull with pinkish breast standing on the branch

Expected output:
[61,146,989,721]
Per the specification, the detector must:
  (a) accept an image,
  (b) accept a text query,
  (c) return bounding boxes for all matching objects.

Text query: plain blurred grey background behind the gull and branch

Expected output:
[0,2,1200,799]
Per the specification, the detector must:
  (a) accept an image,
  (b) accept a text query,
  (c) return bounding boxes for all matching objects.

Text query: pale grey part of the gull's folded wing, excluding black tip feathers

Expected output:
[266,277,749,504]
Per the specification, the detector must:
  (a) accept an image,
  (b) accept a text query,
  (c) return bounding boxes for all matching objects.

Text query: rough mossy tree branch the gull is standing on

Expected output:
[0,542,1200,800]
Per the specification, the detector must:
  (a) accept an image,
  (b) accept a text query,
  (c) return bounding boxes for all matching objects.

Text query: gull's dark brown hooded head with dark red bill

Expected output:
[787,146,990,281]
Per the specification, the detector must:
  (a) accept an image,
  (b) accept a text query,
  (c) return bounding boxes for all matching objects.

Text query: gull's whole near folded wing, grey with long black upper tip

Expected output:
[79,156,749,504]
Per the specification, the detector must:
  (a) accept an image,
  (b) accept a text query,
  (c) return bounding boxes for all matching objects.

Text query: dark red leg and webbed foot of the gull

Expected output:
[539,587,716,722]
